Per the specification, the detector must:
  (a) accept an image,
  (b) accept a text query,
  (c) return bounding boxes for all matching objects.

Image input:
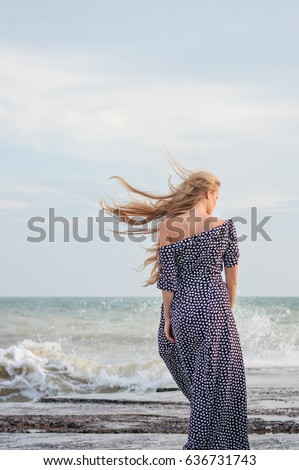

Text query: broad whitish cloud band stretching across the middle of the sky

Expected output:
[0,47,298,159]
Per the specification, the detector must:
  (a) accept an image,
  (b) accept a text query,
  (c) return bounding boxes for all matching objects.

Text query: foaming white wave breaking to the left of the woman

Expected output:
[0,340,169,401]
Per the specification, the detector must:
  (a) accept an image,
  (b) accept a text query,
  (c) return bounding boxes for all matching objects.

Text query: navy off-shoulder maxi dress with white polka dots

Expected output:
[157,219,250,450]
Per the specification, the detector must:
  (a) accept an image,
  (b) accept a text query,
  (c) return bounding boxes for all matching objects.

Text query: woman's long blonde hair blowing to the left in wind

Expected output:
[99,159,220,287]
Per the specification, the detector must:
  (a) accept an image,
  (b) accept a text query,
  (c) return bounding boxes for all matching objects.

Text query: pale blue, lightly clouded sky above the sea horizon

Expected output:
[0,0,299,296]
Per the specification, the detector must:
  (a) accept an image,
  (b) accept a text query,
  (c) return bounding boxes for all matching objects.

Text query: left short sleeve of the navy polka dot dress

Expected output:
[157,245,177,292]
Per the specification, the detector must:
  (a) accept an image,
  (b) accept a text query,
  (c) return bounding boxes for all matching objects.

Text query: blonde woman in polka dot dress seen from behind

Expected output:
[101,159,250,450]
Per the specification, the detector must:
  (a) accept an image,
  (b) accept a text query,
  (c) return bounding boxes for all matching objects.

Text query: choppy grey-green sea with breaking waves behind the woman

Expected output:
[0,296,299,402]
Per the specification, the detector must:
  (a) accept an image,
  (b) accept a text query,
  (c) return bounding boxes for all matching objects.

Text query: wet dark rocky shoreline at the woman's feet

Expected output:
[0,387,299,450]
